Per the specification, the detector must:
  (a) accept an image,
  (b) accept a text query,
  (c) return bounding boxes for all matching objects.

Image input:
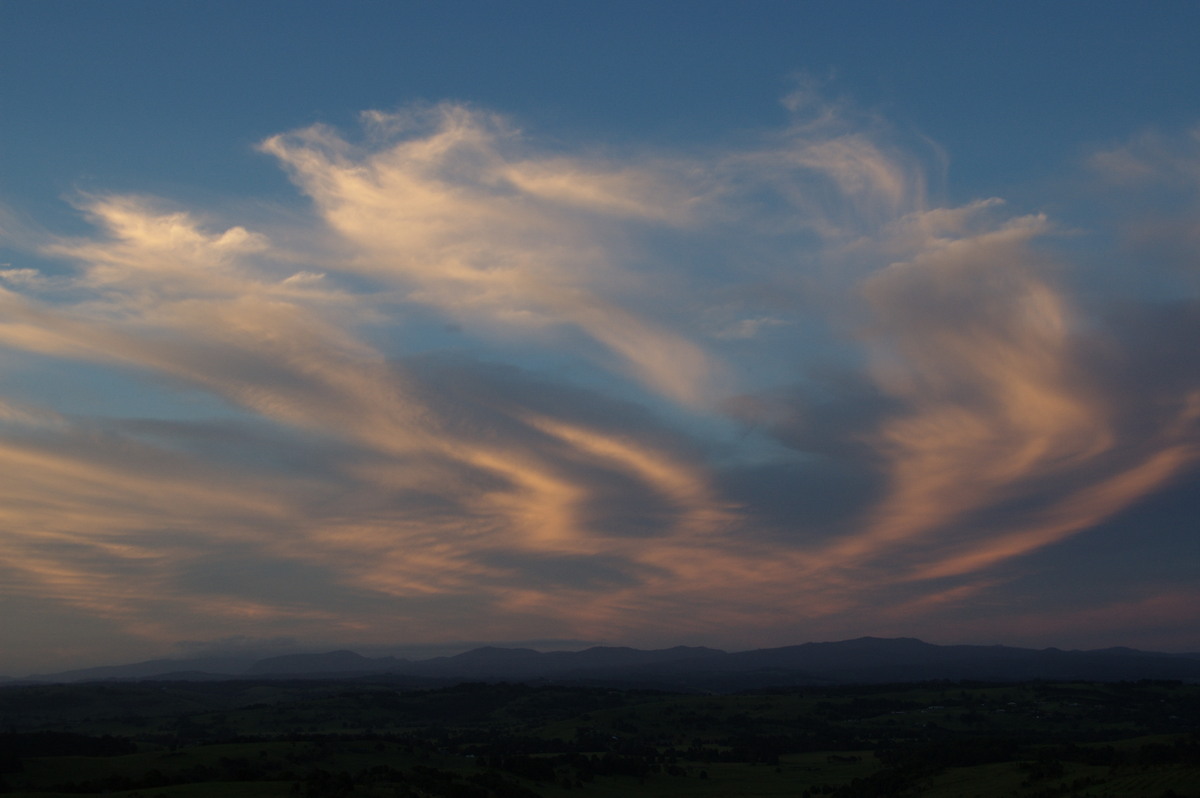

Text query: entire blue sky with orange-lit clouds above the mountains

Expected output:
[0,0,1200,676]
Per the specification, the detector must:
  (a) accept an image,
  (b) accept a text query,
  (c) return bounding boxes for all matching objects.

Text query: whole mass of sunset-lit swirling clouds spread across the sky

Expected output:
[0,91,1200,667]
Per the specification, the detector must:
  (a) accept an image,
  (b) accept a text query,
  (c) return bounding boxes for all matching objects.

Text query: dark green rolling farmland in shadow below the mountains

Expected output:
[0,678,1200,798]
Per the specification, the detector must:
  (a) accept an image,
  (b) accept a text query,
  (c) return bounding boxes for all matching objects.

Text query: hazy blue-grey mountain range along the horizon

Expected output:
[18,637,1200,691]
